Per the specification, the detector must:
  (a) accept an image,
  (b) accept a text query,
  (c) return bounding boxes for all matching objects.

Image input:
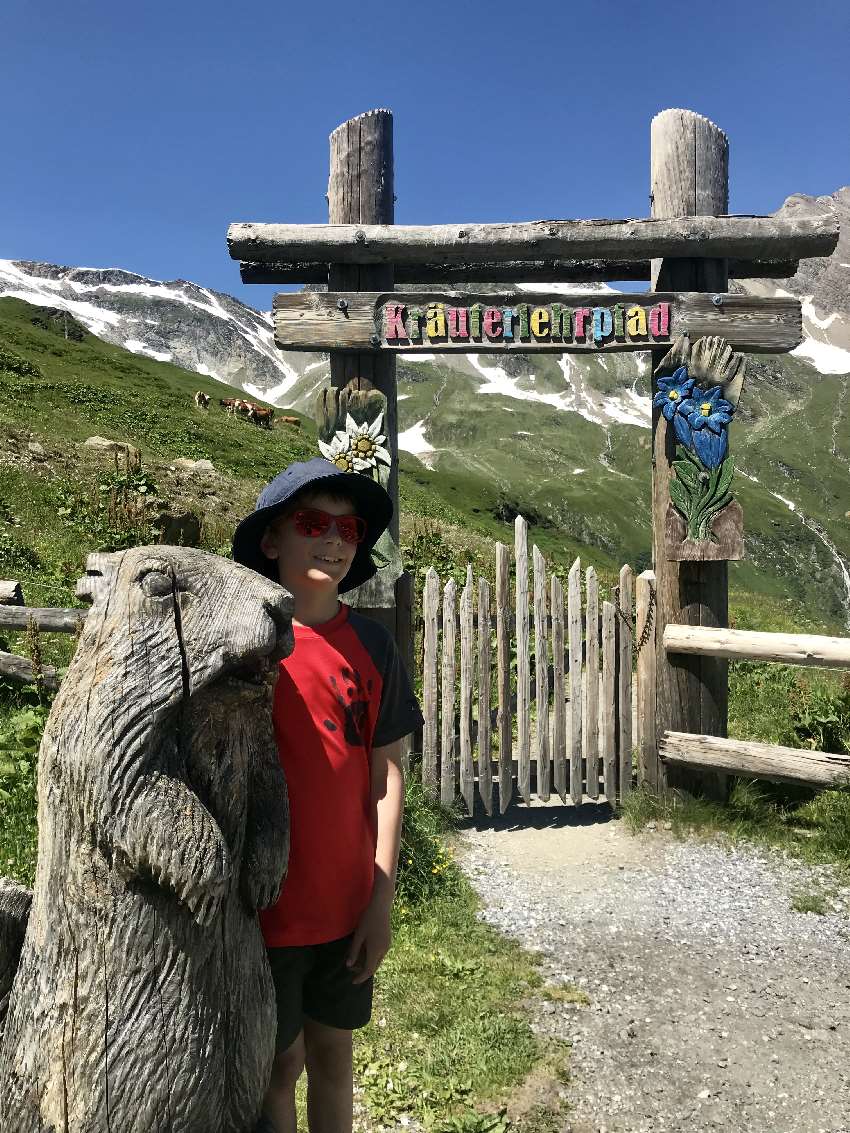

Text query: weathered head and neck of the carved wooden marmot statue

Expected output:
[45,546,292,802]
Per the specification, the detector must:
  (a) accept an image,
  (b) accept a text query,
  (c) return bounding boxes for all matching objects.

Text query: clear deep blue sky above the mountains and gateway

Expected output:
[0,0,850,307]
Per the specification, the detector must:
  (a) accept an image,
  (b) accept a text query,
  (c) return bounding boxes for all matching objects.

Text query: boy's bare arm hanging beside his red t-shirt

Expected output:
[347,740,405,983]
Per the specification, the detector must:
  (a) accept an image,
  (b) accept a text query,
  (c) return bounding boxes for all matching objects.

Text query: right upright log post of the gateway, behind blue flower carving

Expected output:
[649,110,729,798]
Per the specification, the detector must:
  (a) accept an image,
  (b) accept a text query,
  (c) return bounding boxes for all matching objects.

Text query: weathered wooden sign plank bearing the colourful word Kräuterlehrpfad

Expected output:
[272,289,802,356]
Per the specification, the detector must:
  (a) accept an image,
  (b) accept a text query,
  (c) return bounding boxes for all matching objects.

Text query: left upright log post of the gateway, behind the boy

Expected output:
[328,110,405,649]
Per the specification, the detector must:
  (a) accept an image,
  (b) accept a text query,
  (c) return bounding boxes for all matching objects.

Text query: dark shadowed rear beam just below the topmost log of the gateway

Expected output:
[239,259,800,287]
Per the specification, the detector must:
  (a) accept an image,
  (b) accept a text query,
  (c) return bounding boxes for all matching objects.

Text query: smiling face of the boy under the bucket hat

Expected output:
[260,492,357,596]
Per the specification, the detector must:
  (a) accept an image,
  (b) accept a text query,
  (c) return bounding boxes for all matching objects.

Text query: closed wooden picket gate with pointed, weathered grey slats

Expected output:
[420,517,635,815]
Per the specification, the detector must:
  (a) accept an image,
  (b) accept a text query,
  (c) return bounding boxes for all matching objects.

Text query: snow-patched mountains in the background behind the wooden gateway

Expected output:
[0,188,850,625]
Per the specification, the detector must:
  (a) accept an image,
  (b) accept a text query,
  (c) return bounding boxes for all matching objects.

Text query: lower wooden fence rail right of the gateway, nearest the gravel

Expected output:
[658,732,850,786]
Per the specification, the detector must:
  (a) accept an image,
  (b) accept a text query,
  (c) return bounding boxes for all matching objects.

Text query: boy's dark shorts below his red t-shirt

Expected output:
[266,936,372,1050]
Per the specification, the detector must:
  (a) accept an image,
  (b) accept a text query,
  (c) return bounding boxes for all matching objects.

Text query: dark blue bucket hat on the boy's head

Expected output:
[233,457,392,593]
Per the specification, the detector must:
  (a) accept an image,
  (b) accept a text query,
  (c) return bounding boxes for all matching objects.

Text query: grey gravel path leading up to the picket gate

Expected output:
[459,807,850,1133]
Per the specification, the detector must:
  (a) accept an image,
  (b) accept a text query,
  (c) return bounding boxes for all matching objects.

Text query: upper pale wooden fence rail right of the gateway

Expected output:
[666,625,850,668]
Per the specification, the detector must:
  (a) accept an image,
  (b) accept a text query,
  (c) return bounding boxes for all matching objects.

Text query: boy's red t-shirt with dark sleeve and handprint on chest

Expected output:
[260,605,422,947]
